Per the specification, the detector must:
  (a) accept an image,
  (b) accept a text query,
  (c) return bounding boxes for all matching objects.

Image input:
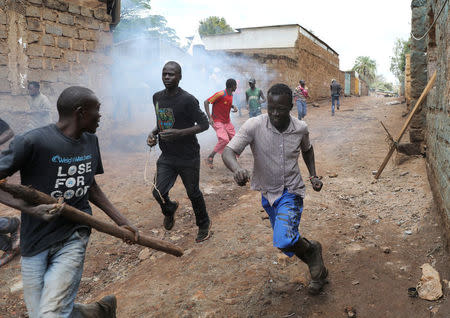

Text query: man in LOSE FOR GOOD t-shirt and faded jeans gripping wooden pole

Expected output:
[0,86,139,318]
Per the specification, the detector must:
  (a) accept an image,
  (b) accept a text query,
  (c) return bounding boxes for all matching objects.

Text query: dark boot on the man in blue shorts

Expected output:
[293,238,328,295]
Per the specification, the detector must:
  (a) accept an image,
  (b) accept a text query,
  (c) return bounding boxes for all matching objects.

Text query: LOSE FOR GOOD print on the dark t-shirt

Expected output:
[50,155,92,200]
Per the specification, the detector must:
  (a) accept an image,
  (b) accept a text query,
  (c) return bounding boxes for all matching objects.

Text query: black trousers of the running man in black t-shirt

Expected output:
[153,156,209,227]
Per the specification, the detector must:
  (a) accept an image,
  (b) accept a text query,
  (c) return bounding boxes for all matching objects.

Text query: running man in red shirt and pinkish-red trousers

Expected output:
[204,78,238,169]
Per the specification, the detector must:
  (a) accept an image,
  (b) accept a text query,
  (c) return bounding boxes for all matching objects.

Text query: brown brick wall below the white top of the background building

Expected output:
[216,33,342,100]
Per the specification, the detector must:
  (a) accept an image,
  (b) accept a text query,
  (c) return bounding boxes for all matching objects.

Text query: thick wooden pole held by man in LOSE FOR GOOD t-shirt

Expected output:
[0,182,183,256]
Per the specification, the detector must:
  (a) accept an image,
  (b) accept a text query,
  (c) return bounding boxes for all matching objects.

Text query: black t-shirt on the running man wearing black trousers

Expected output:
[153,88,209,161]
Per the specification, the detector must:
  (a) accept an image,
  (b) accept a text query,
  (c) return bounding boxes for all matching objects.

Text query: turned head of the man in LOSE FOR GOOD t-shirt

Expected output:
[56,86,101,134]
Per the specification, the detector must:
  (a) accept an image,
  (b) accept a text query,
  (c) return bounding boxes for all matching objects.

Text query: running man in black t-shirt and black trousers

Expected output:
[147,61,211,243]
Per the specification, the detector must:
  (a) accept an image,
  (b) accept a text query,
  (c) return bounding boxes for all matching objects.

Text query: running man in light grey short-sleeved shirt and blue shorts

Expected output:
[222,84,328,294]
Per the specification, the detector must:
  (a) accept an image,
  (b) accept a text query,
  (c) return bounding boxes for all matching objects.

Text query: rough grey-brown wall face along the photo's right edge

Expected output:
[425,0,450,244]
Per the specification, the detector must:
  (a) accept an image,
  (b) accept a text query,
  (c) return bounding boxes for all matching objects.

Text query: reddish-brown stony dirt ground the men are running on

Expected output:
[0,97,450,318]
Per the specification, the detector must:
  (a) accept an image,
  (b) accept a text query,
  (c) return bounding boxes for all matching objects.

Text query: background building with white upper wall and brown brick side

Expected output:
[202,25,342,100]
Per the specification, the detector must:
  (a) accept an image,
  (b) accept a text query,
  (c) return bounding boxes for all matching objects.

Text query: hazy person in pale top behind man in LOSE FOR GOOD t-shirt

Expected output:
[27,82,52,130]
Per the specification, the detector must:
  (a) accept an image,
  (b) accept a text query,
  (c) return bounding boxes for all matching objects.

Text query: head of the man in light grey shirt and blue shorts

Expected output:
[267,84,292,131]
